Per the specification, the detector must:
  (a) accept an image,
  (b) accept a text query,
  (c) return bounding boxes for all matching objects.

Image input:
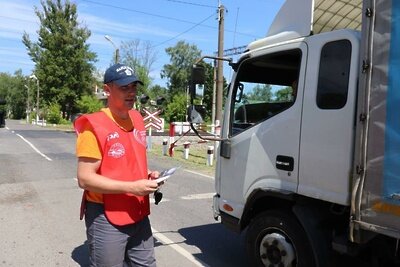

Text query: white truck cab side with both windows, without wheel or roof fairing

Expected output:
[216,30,359,224]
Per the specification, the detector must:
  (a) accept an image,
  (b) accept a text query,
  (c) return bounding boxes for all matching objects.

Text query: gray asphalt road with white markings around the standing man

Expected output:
[0,120,248,267]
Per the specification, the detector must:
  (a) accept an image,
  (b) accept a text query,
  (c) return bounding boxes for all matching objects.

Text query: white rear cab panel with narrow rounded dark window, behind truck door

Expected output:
[298,30,359,205]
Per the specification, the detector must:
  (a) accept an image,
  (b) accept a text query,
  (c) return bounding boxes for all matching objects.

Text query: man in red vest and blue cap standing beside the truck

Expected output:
[74,64,159,266]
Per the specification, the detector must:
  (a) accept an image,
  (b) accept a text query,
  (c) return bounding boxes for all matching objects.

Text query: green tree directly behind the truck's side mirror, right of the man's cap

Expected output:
[161,41,201,99]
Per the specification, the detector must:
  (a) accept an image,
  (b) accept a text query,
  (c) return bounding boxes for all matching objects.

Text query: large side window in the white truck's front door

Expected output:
[231,49,301,135]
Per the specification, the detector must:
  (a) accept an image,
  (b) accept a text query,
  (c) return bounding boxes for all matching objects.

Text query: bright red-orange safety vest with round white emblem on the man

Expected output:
[74,110,150,225]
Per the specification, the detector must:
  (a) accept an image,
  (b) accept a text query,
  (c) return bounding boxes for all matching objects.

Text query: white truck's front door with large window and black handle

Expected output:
[216,42,307,220]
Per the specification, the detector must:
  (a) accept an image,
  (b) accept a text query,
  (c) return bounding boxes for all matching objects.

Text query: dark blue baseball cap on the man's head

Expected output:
[104,63,143,86]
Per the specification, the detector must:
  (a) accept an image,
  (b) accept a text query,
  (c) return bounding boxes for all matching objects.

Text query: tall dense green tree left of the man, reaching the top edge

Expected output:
[22,0,96,118]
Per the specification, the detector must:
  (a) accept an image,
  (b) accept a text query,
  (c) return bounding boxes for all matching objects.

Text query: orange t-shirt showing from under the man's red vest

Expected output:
[76,108,133,203]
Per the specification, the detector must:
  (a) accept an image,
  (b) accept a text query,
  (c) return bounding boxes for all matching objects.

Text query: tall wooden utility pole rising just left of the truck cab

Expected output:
[215,4,225,124]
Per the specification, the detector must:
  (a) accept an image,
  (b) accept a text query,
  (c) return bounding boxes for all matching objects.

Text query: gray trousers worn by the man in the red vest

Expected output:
[85,202,156,267]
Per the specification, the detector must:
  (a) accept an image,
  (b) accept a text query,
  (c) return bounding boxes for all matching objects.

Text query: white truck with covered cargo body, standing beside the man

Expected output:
[189,0,400,267]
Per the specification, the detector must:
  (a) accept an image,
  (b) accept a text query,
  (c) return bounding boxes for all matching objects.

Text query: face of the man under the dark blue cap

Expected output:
[104,83,137,110]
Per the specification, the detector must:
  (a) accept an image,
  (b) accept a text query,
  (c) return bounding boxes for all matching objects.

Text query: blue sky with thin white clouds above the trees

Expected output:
[0,0,284,86]
